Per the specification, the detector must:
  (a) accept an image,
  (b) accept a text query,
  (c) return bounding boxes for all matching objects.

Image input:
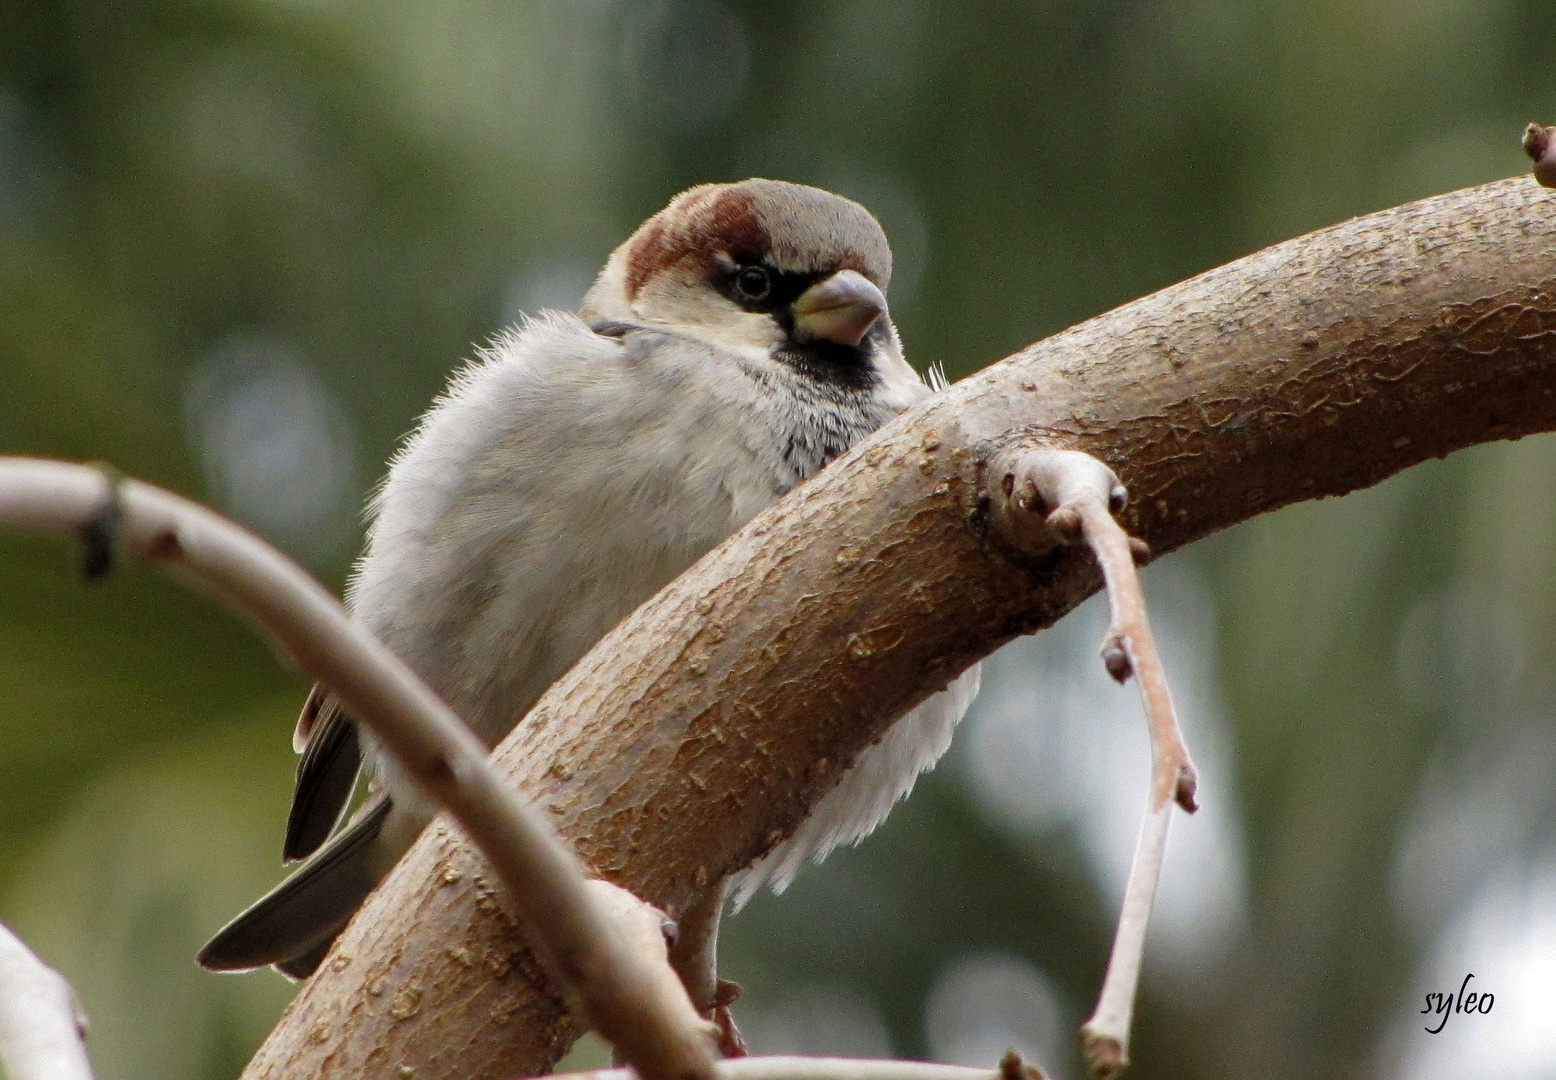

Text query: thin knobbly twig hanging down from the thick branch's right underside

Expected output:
[987,448,1195,1078]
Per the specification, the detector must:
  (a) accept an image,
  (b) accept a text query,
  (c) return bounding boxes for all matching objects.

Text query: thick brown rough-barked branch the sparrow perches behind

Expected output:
[246,179,1556,1080]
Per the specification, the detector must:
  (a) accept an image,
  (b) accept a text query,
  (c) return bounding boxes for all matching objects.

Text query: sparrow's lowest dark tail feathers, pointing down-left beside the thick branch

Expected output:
[199,798,394,977]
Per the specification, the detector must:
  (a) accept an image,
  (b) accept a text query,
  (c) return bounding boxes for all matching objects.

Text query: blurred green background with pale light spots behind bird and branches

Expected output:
[0,0,1556,1080]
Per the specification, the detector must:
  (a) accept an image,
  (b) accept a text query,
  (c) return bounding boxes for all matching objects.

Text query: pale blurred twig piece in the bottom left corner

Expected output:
[0,923,92,1080]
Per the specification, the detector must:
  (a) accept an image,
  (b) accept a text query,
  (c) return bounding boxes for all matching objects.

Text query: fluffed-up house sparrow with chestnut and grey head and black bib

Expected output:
[199,179,977,977]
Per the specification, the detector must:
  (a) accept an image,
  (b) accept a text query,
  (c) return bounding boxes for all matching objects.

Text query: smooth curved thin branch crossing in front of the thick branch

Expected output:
[0,458,713,1080]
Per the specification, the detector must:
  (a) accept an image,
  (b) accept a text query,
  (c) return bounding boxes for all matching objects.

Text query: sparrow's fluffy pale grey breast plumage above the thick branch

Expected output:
[352,313,929,739]
